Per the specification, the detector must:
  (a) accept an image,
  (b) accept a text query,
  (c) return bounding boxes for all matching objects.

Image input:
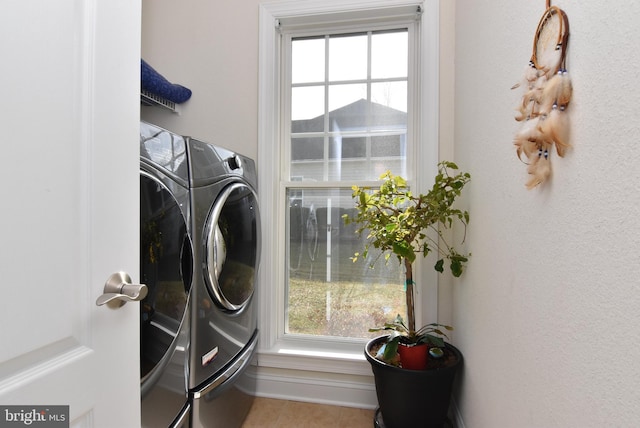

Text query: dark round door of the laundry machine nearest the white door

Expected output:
[140,172,193,381]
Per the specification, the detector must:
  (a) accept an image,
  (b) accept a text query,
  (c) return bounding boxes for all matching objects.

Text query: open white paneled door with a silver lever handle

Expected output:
[0,0,141,428]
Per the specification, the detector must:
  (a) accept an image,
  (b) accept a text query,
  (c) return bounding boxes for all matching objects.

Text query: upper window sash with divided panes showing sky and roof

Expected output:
[290,27,409,183]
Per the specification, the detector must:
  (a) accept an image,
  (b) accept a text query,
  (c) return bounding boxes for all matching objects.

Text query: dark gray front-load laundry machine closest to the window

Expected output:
[187,139,260,428]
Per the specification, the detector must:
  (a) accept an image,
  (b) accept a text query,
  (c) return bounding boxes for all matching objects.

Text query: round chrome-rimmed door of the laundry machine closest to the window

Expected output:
[204,183,260,312]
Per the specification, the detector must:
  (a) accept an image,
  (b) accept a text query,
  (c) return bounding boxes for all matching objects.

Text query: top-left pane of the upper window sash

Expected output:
[291,37,325,84]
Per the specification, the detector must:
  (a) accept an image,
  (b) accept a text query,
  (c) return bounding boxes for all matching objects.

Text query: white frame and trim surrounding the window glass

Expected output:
[258,0,440,375]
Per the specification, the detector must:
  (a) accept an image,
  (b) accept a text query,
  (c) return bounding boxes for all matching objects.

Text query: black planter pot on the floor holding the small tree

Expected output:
[364,336,462,428]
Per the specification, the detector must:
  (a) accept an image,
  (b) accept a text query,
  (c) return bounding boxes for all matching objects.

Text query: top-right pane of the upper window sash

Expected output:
[371,31,409,79]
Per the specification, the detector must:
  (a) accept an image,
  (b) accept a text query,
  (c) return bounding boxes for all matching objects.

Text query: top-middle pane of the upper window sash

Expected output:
[329,34,368,82]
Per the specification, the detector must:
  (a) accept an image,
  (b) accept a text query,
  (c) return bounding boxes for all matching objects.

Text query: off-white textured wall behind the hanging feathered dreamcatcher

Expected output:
[453,0,640,428]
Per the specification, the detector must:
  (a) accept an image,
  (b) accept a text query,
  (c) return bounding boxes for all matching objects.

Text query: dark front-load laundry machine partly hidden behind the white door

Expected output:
[140,123,193,428]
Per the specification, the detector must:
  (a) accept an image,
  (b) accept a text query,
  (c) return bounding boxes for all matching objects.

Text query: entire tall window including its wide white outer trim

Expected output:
[259,0,437,358]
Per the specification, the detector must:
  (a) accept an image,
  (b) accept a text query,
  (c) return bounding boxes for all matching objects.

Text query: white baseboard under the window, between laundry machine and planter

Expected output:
[247,366,378,409]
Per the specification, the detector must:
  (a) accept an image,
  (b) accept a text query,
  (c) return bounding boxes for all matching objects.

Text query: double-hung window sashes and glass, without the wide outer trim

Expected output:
[280,24,413,338]
